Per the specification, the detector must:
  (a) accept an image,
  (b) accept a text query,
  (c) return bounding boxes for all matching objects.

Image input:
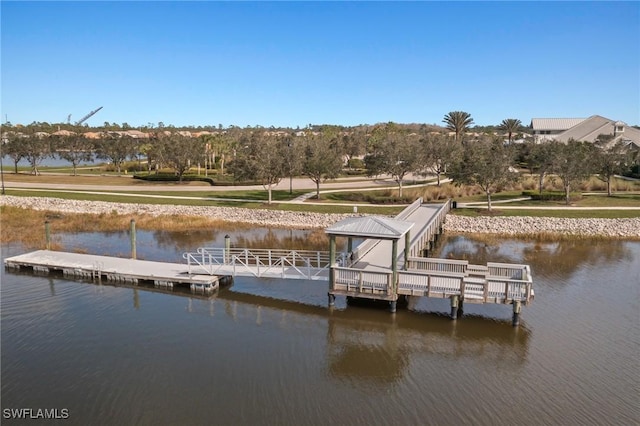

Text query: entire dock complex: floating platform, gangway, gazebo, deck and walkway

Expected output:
[5,198,535,325]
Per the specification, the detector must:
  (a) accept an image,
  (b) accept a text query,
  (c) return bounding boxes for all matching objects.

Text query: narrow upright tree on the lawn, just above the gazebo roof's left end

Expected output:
[302,129,342,200]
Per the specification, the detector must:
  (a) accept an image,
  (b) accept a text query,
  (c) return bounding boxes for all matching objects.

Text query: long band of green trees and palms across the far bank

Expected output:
[2,111,640,206]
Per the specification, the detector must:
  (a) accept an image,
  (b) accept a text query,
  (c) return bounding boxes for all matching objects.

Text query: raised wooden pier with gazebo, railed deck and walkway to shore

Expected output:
[325,199,535,325]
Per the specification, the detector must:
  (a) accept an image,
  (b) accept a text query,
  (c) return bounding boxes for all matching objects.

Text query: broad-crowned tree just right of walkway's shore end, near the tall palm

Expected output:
[448,138,518,211]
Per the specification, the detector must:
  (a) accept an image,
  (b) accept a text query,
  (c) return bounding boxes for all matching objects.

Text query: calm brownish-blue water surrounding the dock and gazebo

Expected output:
[1,230,640,425]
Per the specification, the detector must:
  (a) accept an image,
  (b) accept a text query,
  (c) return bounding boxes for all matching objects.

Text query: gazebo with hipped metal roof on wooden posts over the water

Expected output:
[325,216,414,312]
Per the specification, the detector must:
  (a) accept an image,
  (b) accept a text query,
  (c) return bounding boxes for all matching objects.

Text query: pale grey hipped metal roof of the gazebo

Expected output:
[325,216,414,240]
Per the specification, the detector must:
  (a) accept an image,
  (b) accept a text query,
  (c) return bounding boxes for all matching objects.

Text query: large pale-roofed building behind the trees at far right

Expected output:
[531,115,640,149]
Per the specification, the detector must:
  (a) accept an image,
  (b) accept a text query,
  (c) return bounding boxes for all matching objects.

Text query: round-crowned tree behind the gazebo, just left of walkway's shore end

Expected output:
[365,123,423,197]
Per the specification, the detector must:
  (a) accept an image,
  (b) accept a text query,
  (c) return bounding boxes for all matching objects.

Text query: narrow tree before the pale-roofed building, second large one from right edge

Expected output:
[551,139,594,205]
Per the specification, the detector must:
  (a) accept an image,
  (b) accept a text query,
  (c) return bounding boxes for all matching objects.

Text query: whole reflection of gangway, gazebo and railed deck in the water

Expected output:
[176,290,531,383]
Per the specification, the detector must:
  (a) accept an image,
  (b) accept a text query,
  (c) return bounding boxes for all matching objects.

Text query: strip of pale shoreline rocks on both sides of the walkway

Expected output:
[0,196,640,239]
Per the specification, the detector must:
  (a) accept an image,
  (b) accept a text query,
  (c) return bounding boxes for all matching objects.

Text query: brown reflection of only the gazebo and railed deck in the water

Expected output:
[327,314,530,382]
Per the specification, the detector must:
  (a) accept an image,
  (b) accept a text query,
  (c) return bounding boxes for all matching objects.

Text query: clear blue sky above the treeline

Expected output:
[0,1,640,127]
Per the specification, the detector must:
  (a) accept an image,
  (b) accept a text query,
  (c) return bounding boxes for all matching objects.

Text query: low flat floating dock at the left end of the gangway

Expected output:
[4,250,223,293]
